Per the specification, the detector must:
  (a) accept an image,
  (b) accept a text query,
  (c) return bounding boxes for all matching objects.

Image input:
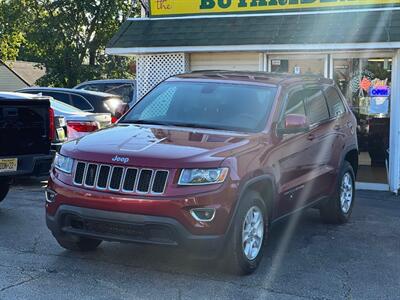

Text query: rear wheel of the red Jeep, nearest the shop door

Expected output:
[320,161,355,224]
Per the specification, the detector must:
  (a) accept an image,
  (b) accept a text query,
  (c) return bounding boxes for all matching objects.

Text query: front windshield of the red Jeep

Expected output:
[120,82,276,132]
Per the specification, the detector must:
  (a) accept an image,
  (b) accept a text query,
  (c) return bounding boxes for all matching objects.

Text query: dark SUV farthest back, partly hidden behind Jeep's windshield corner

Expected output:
[74,79,136,105]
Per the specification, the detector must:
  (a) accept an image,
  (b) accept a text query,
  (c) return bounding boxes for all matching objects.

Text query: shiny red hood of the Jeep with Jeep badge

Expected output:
[61,124,257,168]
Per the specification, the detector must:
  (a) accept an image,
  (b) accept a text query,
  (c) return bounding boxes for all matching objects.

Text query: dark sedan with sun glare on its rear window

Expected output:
[18,87,128,123]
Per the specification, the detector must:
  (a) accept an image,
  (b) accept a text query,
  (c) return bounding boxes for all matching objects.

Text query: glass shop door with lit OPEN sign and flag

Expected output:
[332,55,392,185]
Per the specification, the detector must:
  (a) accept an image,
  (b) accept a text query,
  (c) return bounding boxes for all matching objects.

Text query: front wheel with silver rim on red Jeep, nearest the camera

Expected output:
[225,191,268,275]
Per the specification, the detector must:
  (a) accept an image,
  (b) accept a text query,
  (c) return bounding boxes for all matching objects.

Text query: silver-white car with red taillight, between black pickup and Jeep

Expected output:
[50,99,111,140]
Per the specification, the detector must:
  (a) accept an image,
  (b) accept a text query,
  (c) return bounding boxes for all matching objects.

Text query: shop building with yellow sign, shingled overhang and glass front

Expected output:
[107,0,400,193]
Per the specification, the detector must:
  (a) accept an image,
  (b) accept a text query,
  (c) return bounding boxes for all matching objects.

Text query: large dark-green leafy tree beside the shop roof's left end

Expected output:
[18,0,139,87]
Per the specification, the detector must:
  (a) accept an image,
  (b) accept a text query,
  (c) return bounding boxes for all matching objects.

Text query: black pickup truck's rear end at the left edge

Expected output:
[0,92,55,202]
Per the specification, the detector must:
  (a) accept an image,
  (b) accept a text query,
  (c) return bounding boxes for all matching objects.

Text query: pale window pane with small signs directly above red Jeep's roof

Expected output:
[268,54,328,77]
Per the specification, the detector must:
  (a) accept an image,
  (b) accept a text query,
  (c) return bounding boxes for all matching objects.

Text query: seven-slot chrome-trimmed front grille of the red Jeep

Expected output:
[74,161,168,194]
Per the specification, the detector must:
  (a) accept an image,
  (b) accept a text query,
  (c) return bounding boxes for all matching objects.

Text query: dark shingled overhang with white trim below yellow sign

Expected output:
[107,8,400,55]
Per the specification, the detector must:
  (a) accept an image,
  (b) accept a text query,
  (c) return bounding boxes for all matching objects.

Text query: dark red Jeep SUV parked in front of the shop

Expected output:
[46,71,358,274]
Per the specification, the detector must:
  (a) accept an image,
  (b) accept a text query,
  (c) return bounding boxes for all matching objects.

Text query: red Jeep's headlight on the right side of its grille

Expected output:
[178,168,228,185]
